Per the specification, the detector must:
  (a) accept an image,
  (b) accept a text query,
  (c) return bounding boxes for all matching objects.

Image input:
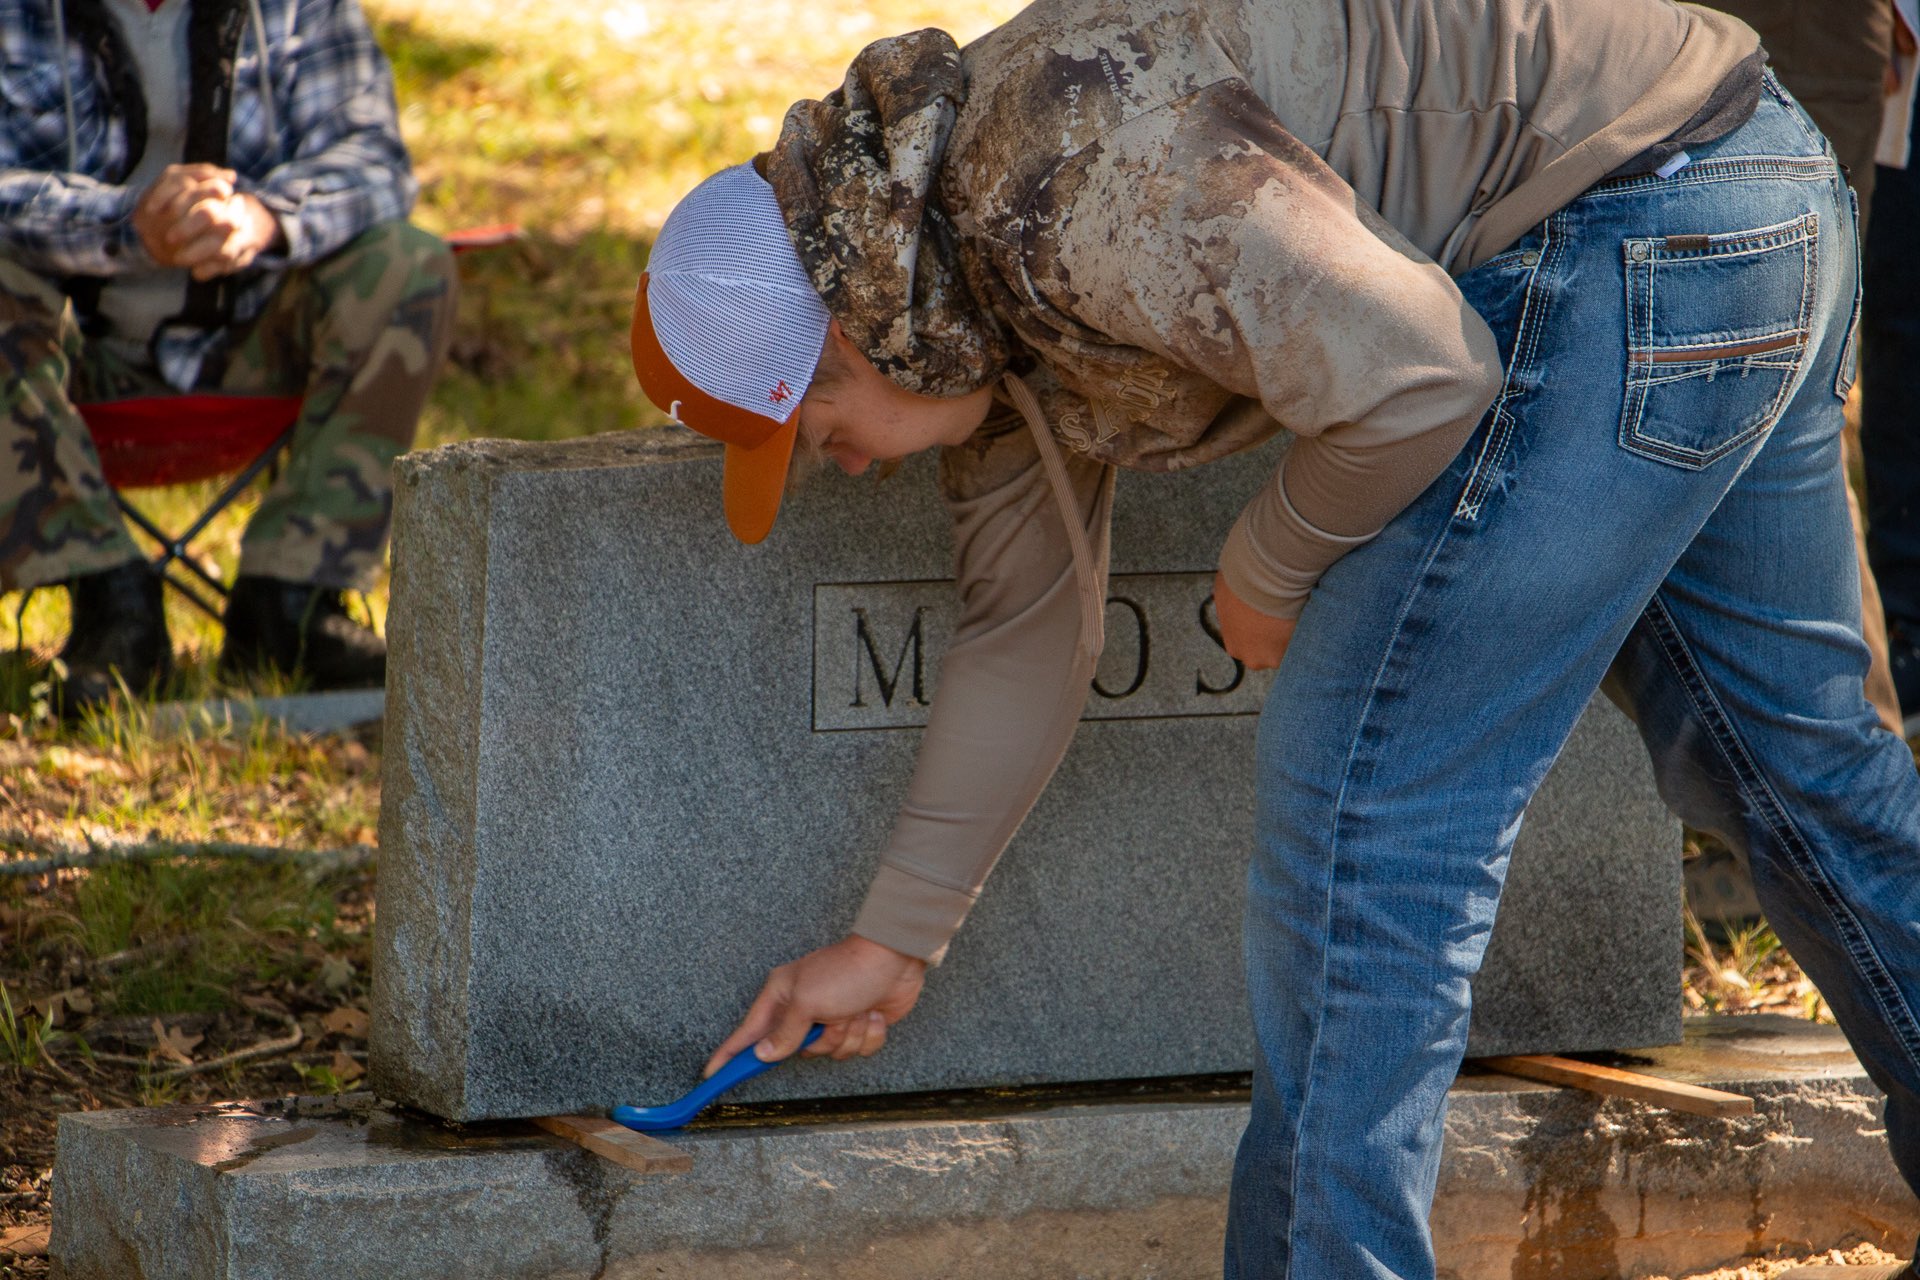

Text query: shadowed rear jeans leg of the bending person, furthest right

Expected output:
[1611,135,1920,1280]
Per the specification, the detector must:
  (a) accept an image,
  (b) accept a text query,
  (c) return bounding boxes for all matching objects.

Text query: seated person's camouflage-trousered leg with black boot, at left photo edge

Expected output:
[0,259,173,714]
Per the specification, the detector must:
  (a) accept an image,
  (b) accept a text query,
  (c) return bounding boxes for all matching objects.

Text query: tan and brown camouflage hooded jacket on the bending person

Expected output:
[766,0,1757,956]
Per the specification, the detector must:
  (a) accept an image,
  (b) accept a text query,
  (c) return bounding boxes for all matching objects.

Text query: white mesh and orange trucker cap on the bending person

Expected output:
[632,163,829,543]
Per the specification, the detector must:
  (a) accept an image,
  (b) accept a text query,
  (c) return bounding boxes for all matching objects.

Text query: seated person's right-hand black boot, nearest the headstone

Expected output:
[221,574,386,689]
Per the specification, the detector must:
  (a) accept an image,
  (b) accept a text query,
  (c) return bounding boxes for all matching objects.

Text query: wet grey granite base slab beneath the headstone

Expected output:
[52,1017,1920,1280]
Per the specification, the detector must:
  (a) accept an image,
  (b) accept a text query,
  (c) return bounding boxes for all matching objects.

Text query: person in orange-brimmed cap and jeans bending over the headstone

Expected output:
[632,0,1920,1280]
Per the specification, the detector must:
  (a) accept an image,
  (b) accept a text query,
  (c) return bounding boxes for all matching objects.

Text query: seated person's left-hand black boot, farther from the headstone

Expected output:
[54,560,173,720]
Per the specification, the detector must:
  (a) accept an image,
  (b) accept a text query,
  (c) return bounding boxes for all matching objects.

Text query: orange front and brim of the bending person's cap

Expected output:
[630,274,801,545]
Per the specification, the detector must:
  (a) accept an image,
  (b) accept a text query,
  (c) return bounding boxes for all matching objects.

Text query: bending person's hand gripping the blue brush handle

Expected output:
[701,935,927,1079]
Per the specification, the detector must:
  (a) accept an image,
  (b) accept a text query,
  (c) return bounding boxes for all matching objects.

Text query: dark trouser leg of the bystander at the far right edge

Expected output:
[1860,107,1920,733]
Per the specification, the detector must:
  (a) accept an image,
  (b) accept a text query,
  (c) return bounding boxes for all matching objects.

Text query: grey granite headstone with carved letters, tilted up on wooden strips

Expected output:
[371,432,1682,1121]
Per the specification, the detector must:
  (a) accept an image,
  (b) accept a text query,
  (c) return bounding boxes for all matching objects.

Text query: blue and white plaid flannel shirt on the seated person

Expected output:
[0,0,419,384]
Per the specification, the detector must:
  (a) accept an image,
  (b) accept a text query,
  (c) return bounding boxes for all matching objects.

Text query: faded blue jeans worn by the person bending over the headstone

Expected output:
[1227,77,1920,1280]
